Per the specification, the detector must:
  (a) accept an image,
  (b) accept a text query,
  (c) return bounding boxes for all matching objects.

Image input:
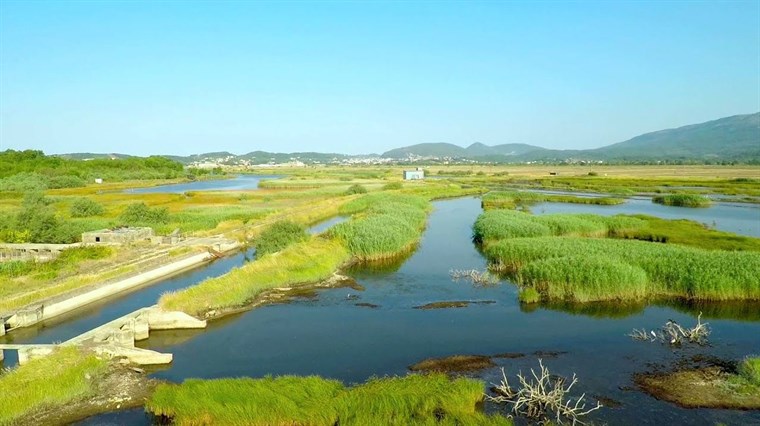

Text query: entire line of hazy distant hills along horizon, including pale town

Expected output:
[60,112,760,166]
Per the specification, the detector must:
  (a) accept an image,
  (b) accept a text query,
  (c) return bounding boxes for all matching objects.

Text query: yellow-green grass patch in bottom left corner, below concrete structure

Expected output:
[0,347,108,425]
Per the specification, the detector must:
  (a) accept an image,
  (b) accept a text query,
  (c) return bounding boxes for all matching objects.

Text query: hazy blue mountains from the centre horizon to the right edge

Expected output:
[382,113,760,162]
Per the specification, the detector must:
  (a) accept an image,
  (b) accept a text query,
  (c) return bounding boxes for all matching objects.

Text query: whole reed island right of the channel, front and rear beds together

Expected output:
[473,198,760,303]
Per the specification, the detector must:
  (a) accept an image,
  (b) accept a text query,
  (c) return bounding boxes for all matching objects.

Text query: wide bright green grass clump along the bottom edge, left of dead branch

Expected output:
[146,374,511,426]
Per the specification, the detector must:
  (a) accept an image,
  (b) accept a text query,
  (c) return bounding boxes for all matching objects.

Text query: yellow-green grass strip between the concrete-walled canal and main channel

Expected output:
[159,237,350,317]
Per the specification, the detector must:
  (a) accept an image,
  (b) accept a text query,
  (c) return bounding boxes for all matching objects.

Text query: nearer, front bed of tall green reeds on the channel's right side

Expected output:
[485,237,760,302]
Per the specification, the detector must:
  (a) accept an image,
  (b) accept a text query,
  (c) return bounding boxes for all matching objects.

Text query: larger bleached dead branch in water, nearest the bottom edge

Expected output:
[486,359,602,425]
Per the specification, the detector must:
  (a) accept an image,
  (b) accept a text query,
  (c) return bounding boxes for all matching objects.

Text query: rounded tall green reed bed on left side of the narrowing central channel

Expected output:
[328,193,430,261]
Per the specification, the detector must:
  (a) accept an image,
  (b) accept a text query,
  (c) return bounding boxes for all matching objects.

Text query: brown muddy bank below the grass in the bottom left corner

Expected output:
[16,363,160,425]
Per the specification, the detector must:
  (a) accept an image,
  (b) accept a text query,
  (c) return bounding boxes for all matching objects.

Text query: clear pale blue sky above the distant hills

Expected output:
[0,0,760,155]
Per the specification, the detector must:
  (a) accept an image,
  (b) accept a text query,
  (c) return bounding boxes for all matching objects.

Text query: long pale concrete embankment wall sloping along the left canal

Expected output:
[0,242,240,333]
